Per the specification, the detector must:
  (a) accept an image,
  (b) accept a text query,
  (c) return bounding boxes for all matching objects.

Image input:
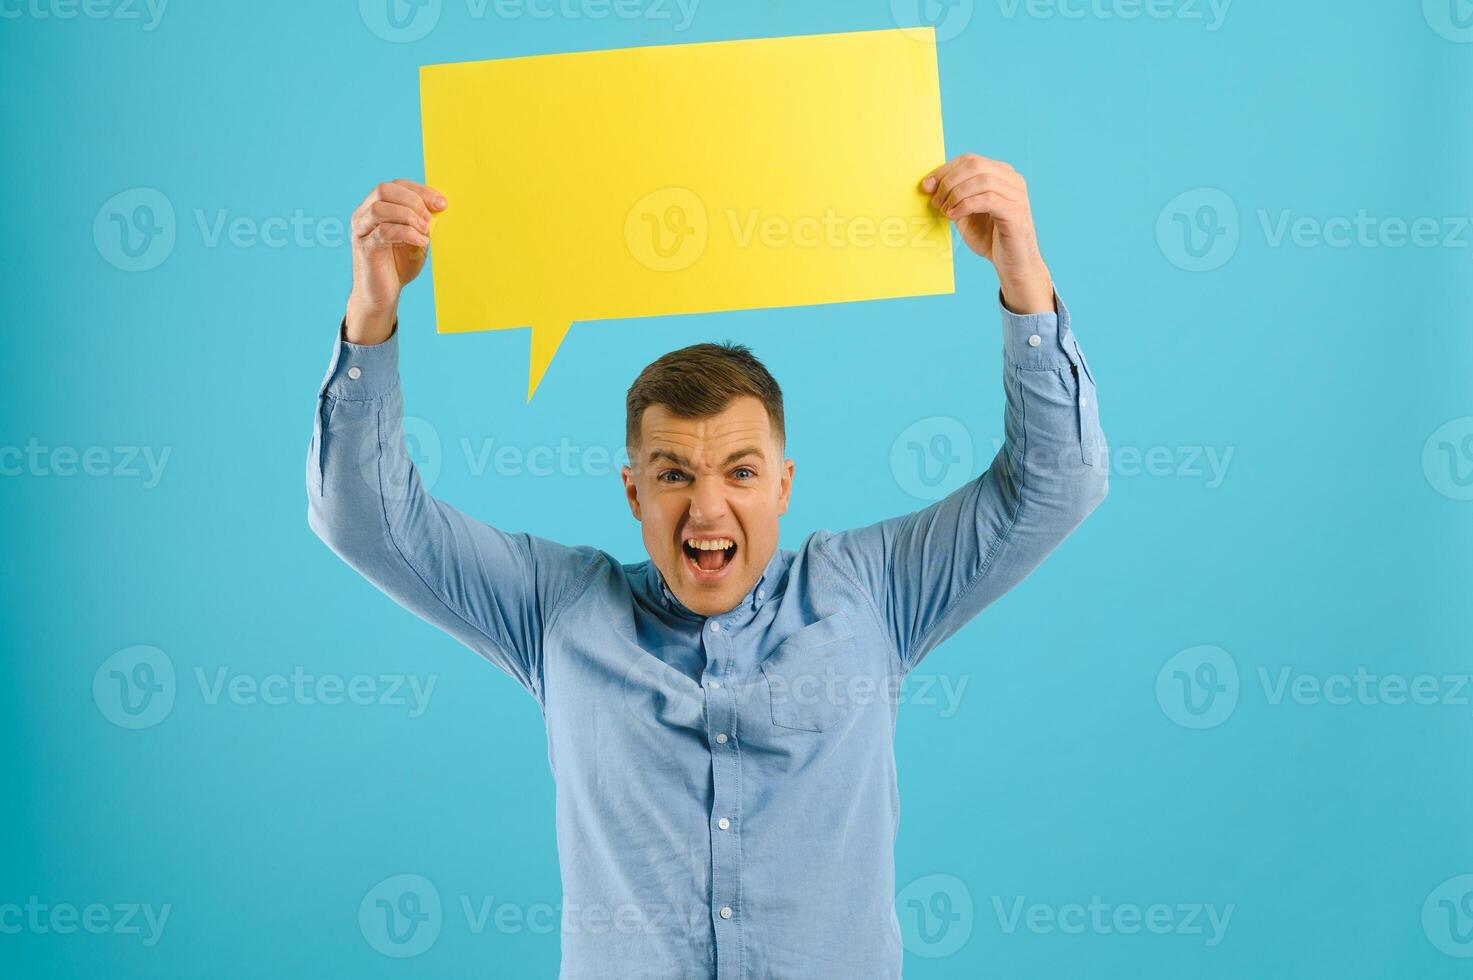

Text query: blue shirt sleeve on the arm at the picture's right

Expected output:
[819,296,1108,672]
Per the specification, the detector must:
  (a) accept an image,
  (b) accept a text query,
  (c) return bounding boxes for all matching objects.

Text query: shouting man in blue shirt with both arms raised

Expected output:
[308,155,1106,980]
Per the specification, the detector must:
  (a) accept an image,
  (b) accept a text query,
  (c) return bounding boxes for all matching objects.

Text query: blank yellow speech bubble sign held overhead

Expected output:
[420,28,955,401]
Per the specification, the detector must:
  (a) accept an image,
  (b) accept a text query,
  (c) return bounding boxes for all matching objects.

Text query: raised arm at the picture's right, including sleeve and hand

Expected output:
[819,155,1108,671]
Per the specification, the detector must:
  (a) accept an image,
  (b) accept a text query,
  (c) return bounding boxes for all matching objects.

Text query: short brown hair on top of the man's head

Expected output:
[625,340,787,449]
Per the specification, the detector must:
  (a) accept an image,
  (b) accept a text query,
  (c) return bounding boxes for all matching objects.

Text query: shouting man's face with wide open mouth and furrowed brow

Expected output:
[623,395,792,616]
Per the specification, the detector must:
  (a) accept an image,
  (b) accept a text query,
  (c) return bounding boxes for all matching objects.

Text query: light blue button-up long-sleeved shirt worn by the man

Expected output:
[306,294,1106,980]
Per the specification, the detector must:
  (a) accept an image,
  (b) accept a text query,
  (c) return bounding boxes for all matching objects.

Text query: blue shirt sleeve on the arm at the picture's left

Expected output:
[306,327,600,703]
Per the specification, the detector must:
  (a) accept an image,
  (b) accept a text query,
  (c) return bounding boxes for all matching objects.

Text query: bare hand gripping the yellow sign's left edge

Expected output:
[346,178,446,345]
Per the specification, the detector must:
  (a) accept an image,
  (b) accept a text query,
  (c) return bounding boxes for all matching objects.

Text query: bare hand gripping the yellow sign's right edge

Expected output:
[921,153,1055,314]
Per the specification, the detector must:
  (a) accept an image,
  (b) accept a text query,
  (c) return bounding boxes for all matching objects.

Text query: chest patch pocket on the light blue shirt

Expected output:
[762,613,854,731]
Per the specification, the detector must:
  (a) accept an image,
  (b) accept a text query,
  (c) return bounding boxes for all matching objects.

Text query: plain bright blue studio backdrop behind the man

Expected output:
[0,0,1473,980]
